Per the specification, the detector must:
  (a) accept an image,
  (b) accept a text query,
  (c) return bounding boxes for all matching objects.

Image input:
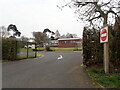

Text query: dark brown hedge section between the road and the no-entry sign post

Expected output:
[83,28,103,66]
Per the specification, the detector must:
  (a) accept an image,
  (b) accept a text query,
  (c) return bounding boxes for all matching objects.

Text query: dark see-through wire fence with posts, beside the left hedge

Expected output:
[16,41,37,59]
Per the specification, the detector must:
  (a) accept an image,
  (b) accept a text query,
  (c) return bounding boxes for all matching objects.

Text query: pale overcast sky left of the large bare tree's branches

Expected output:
[0,0,84,38]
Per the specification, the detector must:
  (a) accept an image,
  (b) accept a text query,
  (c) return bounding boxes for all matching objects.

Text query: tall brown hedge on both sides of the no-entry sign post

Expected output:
[83,25,120,70]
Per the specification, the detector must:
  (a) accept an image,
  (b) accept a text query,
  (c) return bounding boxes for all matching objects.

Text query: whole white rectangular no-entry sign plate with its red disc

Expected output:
[100,27,108,43]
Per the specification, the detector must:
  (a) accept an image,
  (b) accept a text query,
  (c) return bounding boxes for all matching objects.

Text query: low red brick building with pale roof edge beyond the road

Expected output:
[58,38,82,48]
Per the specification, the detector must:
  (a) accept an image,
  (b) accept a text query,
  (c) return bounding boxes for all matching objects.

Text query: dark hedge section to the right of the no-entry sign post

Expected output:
[109,25,120,68]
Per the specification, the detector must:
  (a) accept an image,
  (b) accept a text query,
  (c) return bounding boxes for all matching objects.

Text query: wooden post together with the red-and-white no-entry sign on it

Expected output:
[100,26,109,74]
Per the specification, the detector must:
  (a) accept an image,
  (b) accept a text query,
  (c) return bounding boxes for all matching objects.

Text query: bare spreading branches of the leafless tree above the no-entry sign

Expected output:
[59,0,120,28]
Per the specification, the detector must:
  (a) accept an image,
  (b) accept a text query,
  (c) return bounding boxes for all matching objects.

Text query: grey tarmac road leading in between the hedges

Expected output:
[3,52,96,88]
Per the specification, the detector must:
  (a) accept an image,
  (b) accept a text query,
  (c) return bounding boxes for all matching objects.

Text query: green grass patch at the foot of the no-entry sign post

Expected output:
[87,68,120,88]
